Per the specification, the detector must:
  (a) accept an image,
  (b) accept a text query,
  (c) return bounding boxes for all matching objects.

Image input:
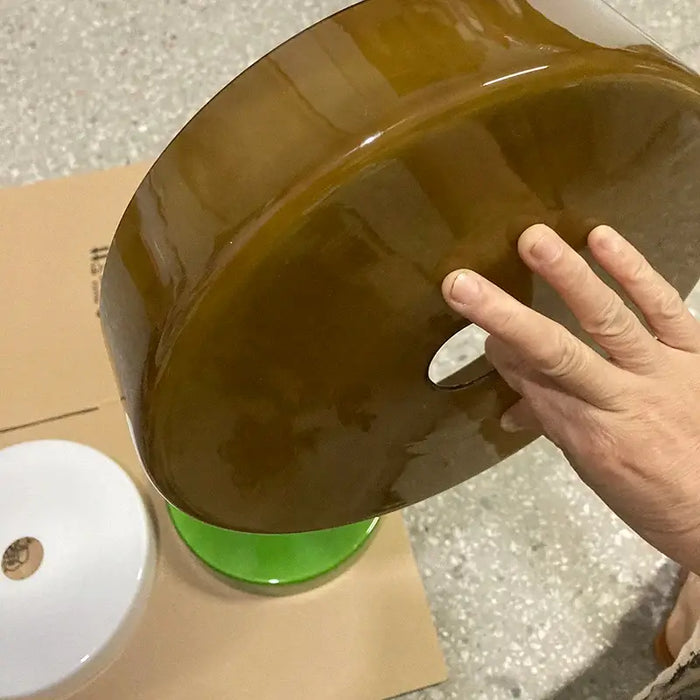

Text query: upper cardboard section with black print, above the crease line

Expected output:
[0,164,147,430]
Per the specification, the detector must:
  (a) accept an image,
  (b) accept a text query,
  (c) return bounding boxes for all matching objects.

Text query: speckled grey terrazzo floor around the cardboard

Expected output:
[0,0,700,700]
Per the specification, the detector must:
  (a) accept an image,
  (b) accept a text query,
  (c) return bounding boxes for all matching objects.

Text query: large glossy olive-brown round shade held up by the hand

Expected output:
[101,0,700,533]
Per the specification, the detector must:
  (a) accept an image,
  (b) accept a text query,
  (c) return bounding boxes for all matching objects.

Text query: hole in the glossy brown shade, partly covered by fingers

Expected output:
[428,323,493,389]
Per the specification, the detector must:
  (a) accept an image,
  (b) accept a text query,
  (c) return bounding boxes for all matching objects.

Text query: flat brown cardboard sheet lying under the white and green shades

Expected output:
[0,165,446,700]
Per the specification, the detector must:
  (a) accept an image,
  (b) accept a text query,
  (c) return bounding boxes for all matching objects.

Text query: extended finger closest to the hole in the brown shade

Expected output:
[442,270,623,408]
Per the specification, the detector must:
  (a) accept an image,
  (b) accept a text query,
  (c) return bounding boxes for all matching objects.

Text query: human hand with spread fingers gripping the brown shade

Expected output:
[443,225,700,573]
